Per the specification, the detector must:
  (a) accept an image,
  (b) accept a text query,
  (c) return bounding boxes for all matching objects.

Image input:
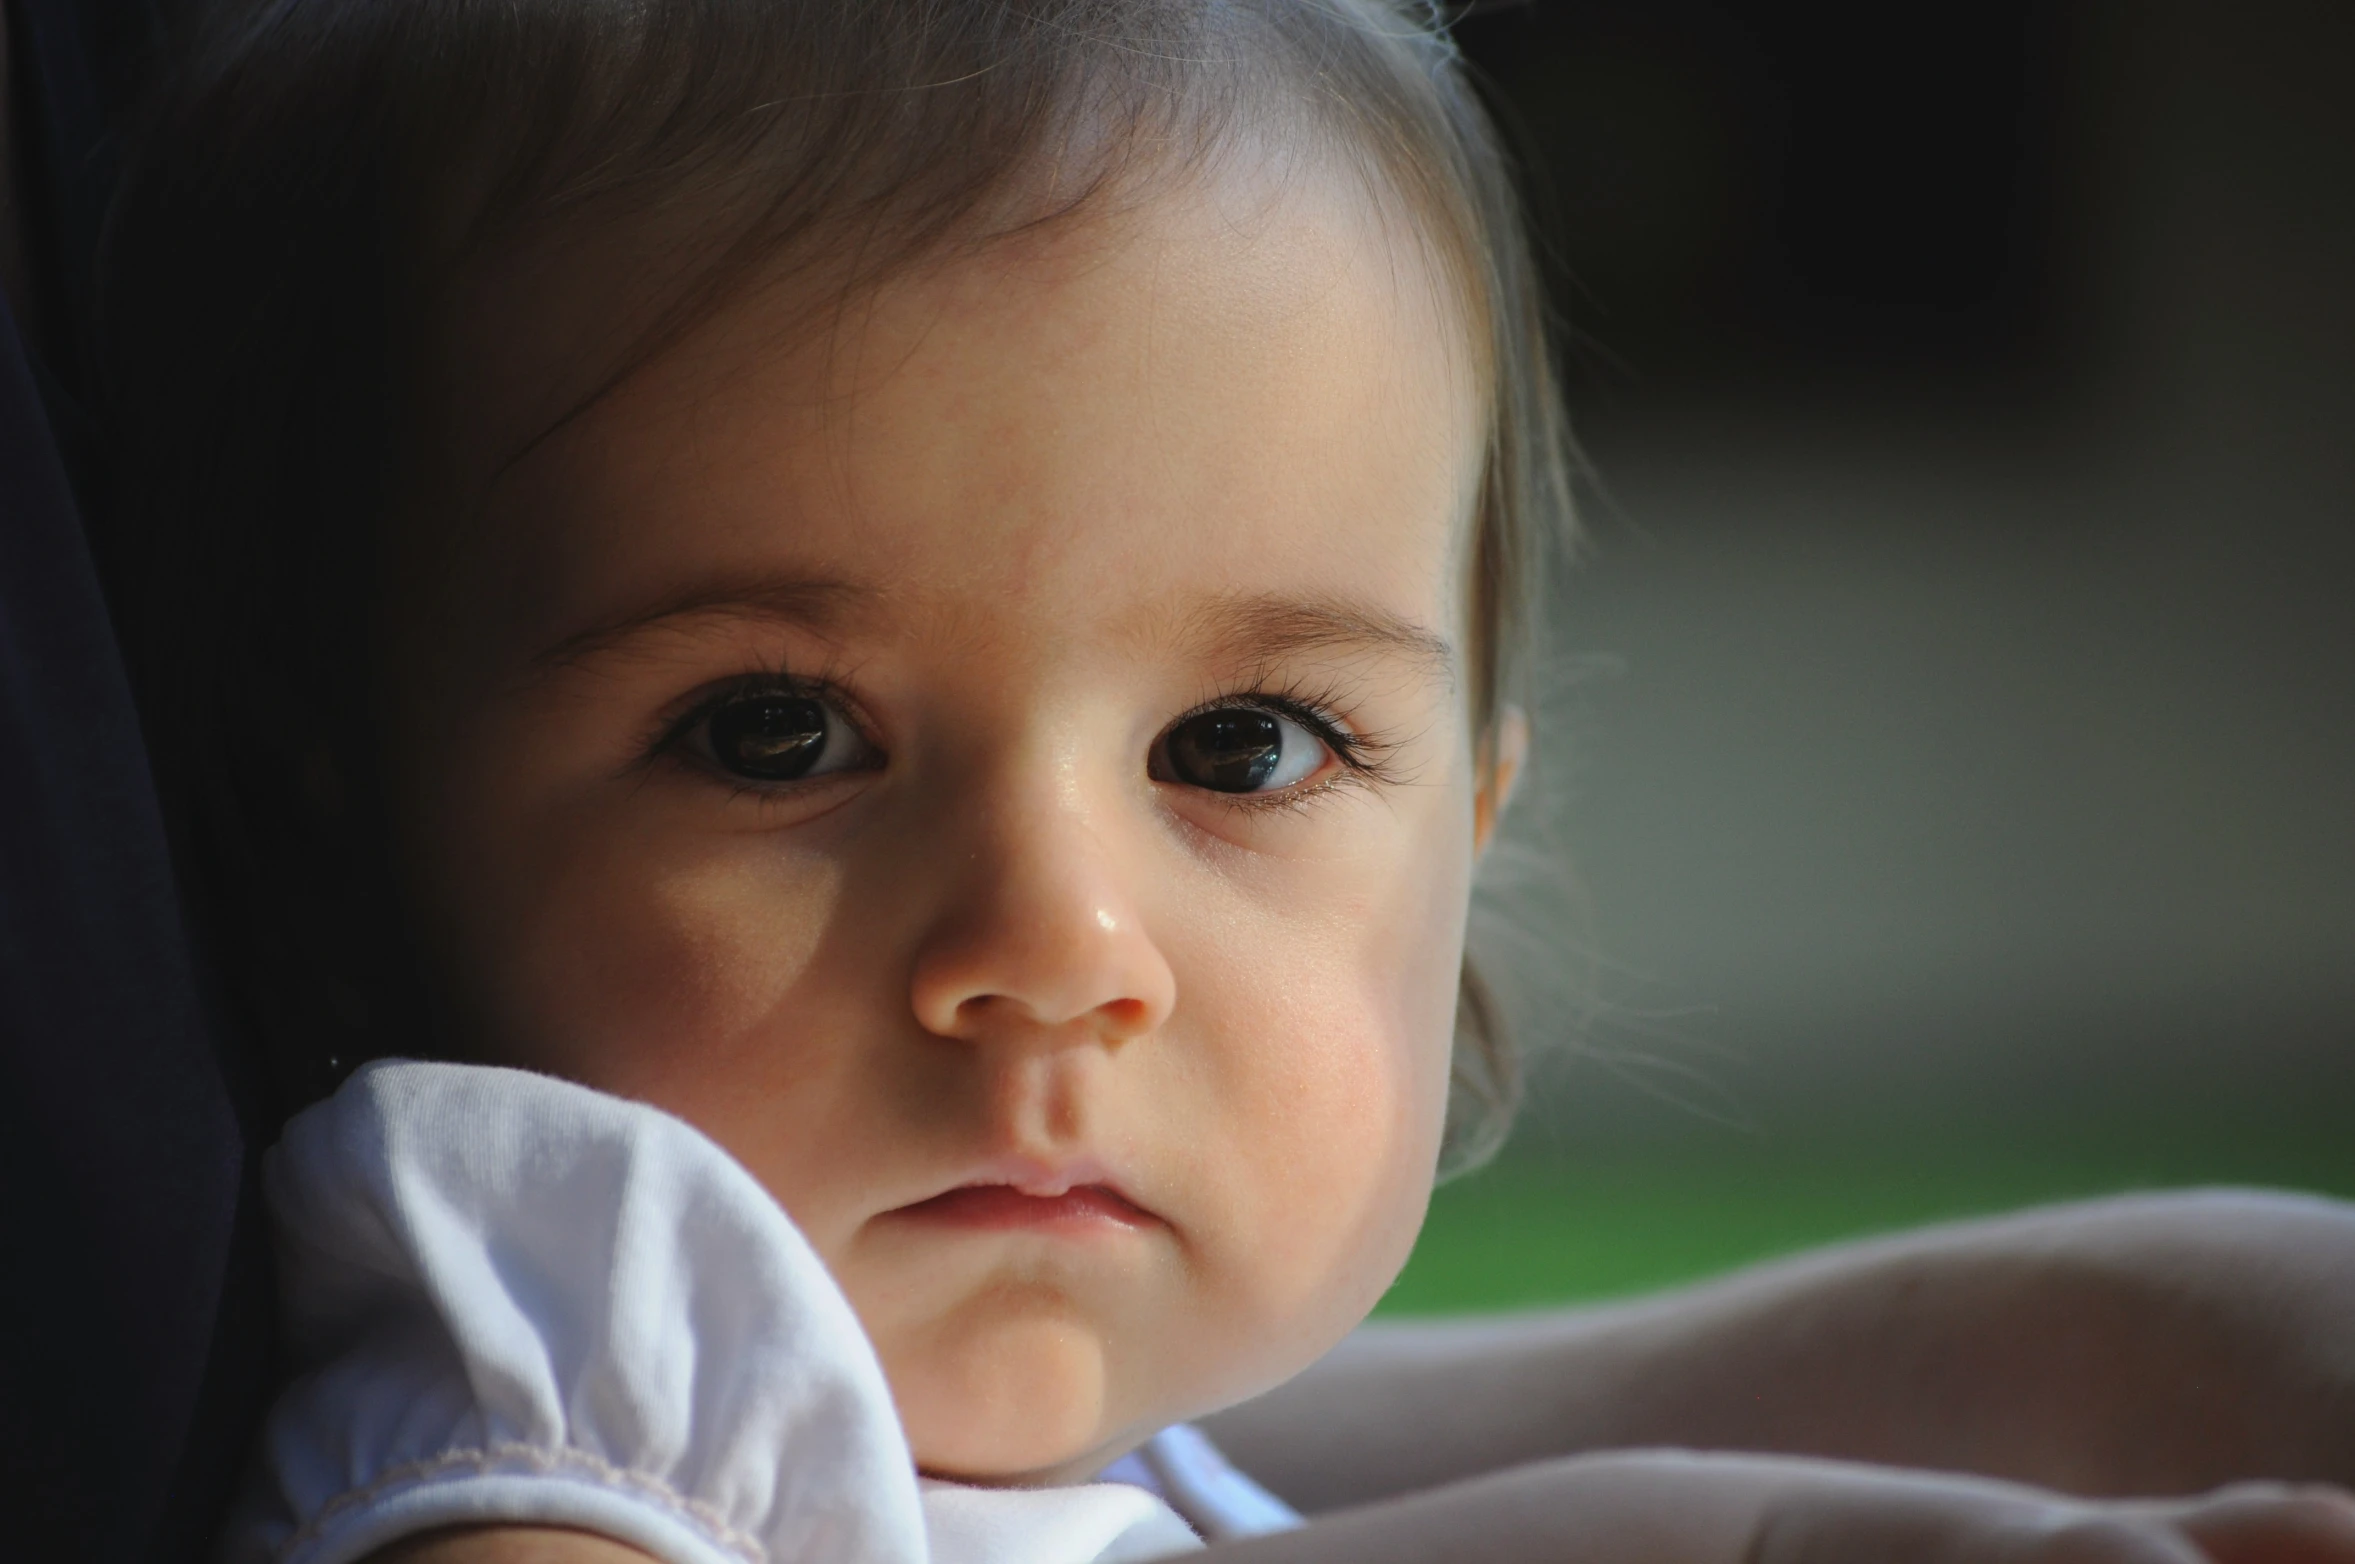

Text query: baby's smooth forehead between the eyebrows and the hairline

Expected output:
[433,153,1484,678]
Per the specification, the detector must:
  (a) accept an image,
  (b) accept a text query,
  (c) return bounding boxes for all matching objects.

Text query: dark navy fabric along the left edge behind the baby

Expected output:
[0,0,271,1564]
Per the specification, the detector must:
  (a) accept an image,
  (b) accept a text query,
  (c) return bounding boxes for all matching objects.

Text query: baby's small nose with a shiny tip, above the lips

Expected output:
[909,777,1178,1043]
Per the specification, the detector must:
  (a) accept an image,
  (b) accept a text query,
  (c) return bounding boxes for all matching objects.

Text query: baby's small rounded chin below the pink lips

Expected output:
[883,1314,1121,1484]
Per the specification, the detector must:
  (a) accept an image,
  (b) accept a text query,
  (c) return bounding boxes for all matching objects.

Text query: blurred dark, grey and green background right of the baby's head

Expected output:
[1385,0,2355,1312]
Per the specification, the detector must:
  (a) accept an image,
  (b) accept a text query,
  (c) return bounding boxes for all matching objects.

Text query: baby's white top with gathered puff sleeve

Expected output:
[224,1062,1196,1564]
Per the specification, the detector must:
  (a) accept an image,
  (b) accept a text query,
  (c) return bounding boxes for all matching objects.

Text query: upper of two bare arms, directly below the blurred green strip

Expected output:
[1208,1192,2355,1512]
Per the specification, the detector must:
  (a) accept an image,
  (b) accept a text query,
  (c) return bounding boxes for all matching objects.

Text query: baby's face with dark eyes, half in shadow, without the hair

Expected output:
[393,155,1488,1479]
